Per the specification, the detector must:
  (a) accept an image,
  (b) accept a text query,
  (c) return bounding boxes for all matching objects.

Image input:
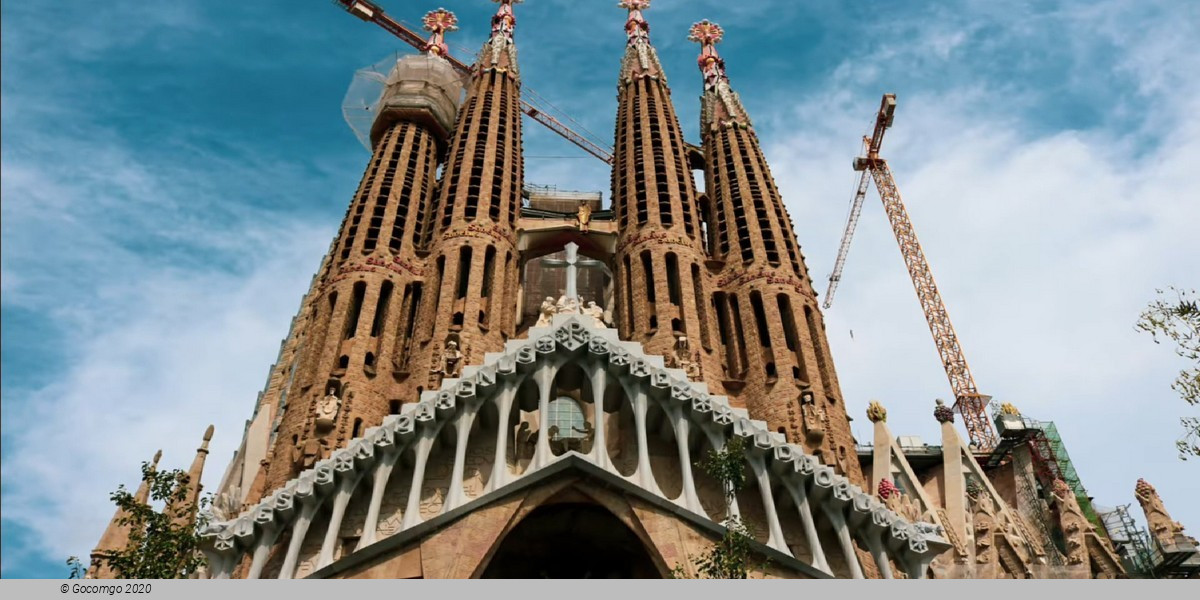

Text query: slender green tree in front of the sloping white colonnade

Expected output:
[673,437,754,580]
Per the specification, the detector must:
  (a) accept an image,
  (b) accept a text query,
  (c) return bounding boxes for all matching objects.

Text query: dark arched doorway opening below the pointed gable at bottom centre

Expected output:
[482,503,661,580]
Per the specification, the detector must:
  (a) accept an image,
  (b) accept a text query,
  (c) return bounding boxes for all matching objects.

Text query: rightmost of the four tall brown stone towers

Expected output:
[689,20,862,481]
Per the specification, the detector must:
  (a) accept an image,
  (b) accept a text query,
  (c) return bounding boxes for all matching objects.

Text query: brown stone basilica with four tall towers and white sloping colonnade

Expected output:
[91,0,1200,578]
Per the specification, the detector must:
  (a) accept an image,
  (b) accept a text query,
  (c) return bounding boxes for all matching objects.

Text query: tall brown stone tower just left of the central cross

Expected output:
[415,0,524,390]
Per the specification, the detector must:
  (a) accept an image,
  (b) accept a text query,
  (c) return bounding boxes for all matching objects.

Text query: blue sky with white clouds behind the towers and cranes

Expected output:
[0,0,1200,577]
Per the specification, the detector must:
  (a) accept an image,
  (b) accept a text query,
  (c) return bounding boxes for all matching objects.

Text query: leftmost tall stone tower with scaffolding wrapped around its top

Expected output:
[265,8,462,492]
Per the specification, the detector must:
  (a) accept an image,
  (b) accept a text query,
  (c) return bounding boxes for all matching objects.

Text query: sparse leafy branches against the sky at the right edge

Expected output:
[1136,287,1200,461]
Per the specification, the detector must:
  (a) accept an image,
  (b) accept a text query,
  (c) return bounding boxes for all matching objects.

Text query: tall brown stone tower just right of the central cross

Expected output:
[612,0,720,379]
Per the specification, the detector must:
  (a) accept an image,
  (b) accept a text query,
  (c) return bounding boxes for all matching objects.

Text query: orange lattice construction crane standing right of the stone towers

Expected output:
[824,94,998,451]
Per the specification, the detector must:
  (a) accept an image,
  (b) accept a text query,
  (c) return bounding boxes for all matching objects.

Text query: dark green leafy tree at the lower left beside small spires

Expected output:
[67,462,209,580]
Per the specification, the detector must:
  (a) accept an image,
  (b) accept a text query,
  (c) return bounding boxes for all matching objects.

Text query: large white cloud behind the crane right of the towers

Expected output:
[764,2,1200,537]
